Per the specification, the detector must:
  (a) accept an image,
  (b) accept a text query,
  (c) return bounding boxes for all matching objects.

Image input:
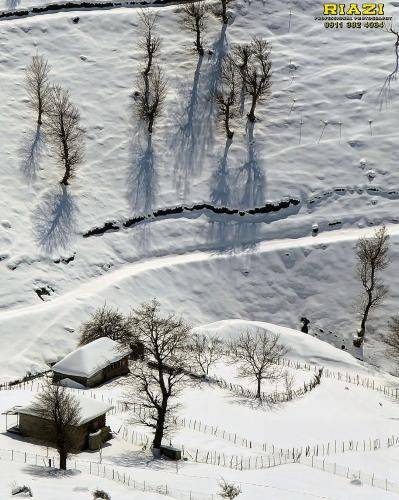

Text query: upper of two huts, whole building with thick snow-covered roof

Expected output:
[53,337,131,387]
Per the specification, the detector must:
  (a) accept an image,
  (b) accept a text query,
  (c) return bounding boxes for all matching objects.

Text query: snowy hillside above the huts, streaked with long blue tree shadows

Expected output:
[0,0,399,377]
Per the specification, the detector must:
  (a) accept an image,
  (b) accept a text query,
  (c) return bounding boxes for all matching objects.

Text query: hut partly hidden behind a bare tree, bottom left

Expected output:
[17,396,112,451]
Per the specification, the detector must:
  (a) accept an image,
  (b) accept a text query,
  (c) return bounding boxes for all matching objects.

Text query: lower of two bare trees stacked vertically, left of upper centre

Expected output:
[136,66,167,134]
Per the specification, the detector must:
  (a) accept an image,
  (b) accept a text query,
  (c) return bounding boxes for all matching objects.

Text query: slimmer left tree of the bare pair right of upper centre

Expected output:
[214,56,238,139]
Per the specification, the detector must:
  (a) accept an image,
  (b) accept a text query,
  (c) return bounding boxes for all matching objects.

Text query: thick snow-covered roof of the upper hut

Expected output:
[53,337,130,377]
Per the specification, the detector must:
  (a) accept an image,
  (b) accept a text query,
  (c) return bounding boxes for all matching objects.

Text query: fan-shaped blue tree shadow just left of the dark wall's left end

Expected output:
[32,185,77,253]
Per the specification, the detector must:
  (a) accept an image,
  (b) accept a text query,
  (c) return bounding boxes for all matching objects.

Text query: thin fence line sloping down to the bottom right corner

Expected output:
[298,457,399,493]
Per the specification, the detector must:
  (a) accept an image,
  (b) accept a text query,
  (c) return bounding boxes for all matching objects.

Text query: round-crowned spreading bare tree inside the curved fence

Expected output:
[229,329,287,399]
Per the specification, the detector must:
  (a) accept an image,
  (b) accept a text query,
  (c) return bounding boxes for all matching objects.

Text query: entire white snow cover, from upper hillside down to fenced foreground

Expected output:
[0,0,399,500]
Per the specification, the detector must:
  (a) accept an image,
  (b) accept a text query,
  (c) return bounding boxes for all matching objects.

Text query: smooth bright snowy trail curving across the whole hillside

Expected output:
[0,224,399,321]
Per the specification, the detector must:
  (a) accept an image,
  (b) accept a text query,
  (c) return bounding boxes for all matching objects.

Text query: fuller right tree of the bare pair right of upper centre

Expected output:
[238,38,272,122]
